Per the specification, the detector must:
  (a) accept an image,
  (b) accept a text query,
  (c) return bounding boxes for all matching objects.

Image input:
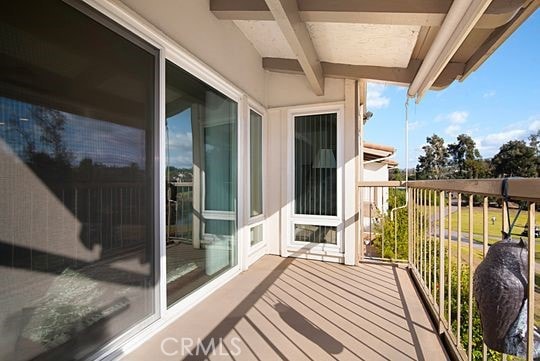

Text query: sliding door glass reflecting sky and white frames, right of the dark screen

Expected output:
[166,62,237,306]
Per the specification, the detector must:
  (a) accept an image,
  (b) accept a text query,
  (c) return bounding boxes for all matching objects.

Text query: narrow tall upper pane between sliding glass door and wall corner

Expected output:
[249,110,263,217]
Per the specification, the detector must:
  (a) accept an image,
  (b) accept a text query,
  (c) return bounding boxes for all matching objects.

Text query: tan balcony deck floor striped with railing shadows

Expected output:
[124,256,448,361]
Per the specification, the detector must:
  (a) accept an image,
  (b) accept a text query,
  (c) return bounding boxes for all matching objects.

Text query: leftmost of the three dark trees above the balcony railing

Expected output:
[416,134,448,179]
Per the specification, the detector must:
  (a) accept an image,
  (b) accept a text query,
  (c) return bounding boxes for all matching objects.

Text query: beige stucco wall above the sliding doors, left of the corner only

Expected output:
[122,0,265,104]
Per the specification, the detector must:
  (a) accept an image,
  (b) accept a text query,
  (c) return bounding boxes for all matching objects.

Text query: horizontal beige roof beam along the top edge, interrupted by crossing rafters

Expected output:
[210,0,526,29]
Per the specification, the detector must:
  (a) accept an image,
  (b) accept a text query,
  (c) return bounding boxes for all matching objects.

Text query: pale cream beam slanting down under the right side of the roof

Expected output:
[408,0,492,103]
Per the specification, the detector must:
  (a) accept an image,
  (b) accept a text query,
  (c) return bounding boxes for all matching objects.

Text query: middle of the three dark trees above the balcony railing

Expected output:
[448,134,489,179]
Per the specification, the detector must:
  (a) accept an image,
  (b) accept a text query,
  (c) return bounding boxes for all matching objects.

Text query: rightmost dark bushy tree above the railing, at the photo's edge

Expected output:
[492,140,538,177]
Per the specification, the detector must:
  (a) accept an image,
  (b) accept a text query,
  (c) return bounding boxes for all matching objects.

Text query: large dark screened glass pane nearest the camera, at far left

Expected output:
[0,0,157,360]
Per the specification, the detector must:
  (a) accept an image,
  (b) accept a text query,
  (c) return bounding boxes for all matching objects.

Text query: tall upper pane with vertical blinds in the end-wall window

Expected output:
[294,113,337,216]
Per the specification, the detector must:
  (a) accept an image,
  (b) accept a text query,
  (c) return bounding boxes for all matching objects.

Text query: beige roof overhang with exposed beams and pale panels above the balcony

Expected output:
[210,0,540,100]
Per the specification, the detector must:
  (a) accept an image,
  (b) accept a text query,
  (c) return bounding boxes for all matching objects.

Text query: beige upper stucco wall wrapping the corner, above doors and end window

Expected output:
[122,0,345,108]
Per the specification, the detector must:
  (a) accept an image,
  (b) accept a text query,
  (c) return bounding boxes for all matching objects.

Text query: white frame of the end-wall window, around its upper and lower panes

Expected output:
[286,103,345,254]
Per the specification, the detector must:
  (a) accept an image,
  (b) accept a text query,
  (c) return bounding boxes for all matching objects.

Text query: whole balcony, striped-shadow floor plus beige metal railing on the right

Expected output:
[123,179,540,360]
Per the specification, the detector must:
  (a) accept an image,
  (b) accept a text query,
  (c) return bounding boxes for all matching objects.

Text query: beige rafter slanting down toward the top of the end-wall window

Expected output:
[266,0,324,95]
